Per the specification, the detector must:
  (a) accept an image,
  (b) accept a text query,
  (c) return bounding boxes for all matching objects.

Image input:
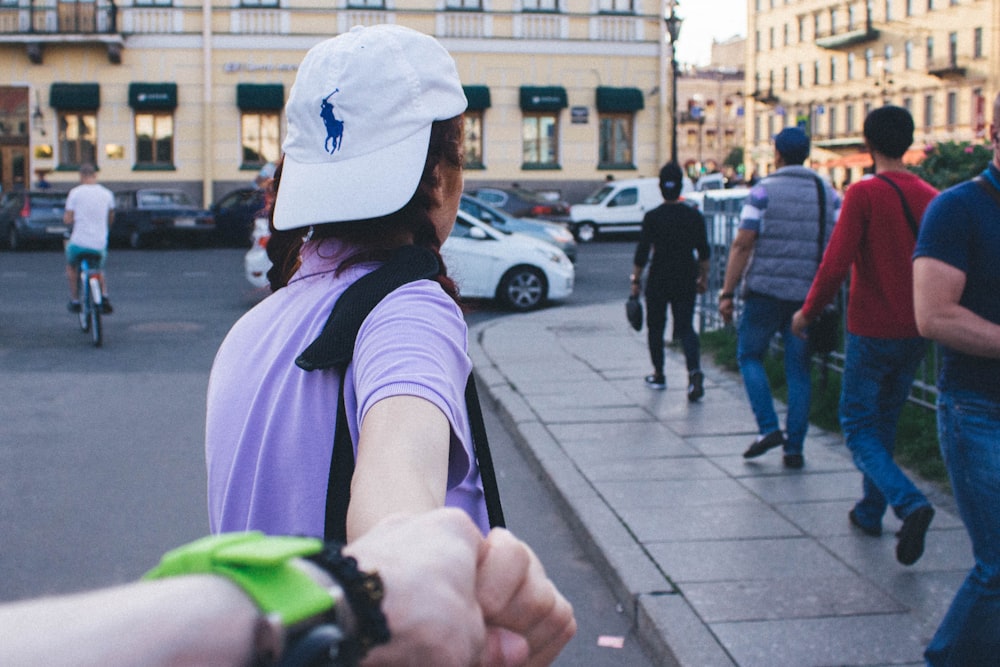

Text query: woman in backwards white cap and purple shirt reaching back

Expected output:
[206,25,489,538]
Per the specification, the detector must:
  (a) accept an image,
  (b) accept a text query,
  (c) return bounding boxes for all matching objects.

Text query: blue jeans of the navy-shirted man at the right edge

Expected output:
[924,391,1000,667]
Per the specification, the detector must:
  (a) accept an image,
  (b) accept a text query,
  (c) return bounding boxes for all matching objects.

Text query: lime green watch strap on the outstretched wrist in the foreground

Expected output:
[143,531,336,627]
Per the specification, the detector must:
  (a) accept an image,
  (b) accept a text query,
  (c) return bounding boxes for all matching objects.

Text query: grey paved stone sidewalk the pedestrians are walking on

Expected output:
[470,303,973,667]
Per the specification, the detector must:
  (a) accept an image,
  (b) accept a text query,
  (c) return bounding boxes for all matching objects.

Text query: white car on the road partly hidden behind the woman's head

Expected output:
[244,211,576,311]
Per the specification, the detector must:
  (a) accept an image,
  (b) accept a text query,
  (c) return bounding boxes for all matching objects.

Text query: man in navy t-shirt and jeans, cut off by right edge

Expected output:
[913,90,1000,667]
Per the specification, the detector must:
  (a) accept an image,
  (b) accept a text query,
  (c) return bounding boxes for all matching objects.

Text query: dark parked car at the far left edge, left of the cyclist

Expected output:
[0,190,69,250]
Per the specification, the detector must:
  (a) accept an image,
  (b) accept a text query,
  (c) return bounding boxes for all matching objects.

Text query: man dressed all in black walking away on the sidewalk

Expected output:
[630,162,709,401]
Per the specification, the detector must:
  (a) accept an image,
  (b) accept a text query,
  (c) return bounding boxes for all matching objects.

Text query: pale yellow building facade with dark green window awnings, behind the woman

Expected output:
[0,0,669,204]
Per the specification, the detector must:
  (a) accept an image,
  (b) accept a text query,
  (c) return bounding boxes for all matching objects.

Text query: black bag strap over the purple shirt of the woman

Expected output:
[295,245,504,541]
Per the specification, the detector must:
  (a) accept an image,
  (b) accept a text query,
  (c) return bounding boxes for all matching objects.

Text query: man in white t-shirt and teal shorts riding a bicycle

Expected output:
[63,164,115,314]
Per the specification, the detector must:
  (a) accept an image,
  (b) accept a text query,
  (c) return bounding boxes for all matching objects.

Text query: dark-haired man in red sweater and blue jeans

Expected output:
[792,106,937,565]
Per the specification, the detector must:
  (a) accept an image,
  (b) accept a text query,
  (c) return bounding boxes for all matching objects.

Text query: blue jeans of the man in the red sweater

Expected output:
[840,333,928,528]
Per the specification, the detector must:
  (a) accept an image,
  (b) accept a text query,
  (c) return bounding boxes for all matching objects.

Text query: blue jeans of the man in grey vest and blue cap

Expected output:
[736,294,812,454]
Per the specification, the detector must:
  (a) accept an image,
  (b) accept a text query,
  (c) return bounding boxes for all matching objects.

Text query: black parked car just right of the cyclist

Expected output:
[110,188,215,248]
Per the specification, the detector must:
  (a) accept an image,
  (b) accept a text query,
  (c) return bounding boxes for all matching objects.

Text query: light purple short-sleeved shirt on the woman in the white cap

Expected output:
[205,240,489,537]
